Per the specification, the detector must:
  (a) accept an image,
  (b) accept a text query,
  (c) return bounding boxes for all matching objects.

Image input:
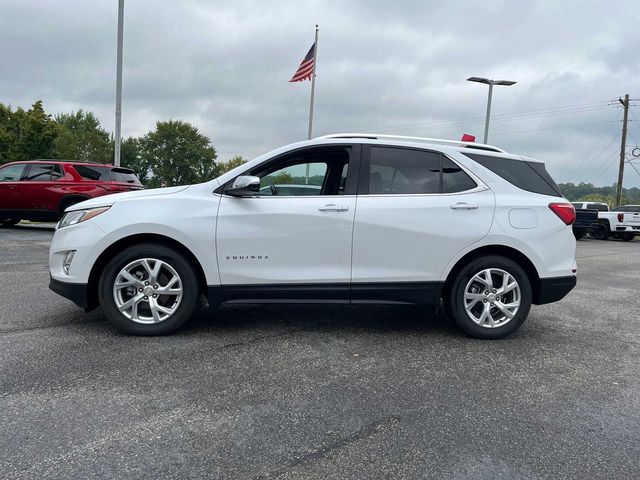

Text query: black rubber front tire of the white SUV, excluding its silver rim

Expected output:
[98,244,200,335]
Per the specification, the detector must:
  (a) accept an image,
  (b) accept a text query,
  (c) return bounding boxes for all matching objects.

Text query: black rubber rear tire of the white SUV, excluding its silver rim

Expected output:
[448,255,533,339]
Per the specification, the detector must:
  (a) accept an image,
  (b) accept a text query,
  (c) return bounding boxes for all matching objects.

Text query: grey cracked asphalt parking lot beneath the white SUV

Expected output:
[0,226,640,479]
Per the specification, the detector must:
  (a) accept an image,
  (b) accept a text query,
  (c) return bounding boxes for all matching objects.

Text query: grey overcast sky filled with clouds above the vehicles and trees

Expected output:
[0,0,640,186]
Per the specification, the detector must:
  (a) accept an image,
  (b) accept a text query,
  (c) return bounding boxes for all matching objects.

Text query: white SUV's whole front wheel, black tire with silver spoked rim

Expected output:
[98,243,200,335]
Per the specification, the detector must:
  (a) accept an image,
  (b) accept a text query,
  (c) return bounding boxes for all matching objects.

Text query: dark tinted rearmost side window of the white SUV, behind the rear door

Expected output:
[464,153,563,197]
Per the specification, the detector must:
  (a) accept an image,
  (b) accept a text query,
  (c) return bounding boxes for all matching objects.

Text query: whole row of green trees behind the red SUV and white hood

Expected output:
[0,100,245,188]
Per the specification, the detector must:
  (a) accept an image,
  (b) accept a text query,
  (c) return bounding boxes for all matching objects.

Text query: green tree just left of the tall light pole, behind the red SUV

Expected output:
[54,109,113,163]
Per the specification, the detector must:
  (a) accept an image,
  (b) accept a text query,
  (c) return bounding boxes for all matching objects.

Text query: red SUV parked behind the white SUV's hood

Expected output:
[0,160,143,225]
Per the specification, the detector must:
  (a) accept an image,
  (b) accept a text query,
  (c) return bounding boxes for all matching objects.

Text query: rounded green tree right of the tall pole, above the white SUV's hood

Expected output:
[139,120,217,187]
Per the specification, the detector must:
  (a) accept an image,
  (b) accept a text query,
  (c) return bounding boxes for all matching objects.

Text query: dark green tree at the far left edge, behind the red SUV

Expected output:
[0,100,58,163]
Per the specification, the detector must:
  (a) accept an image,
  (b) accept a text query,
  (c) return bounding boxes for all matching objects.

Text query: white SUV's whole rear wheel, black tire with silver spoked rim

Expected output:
[445,255,532,339]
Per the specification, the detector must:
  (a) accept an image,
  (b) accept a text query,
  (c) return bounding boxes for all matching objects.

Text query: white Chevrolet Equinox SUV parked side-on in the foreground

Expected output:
[49,134,576,338]
